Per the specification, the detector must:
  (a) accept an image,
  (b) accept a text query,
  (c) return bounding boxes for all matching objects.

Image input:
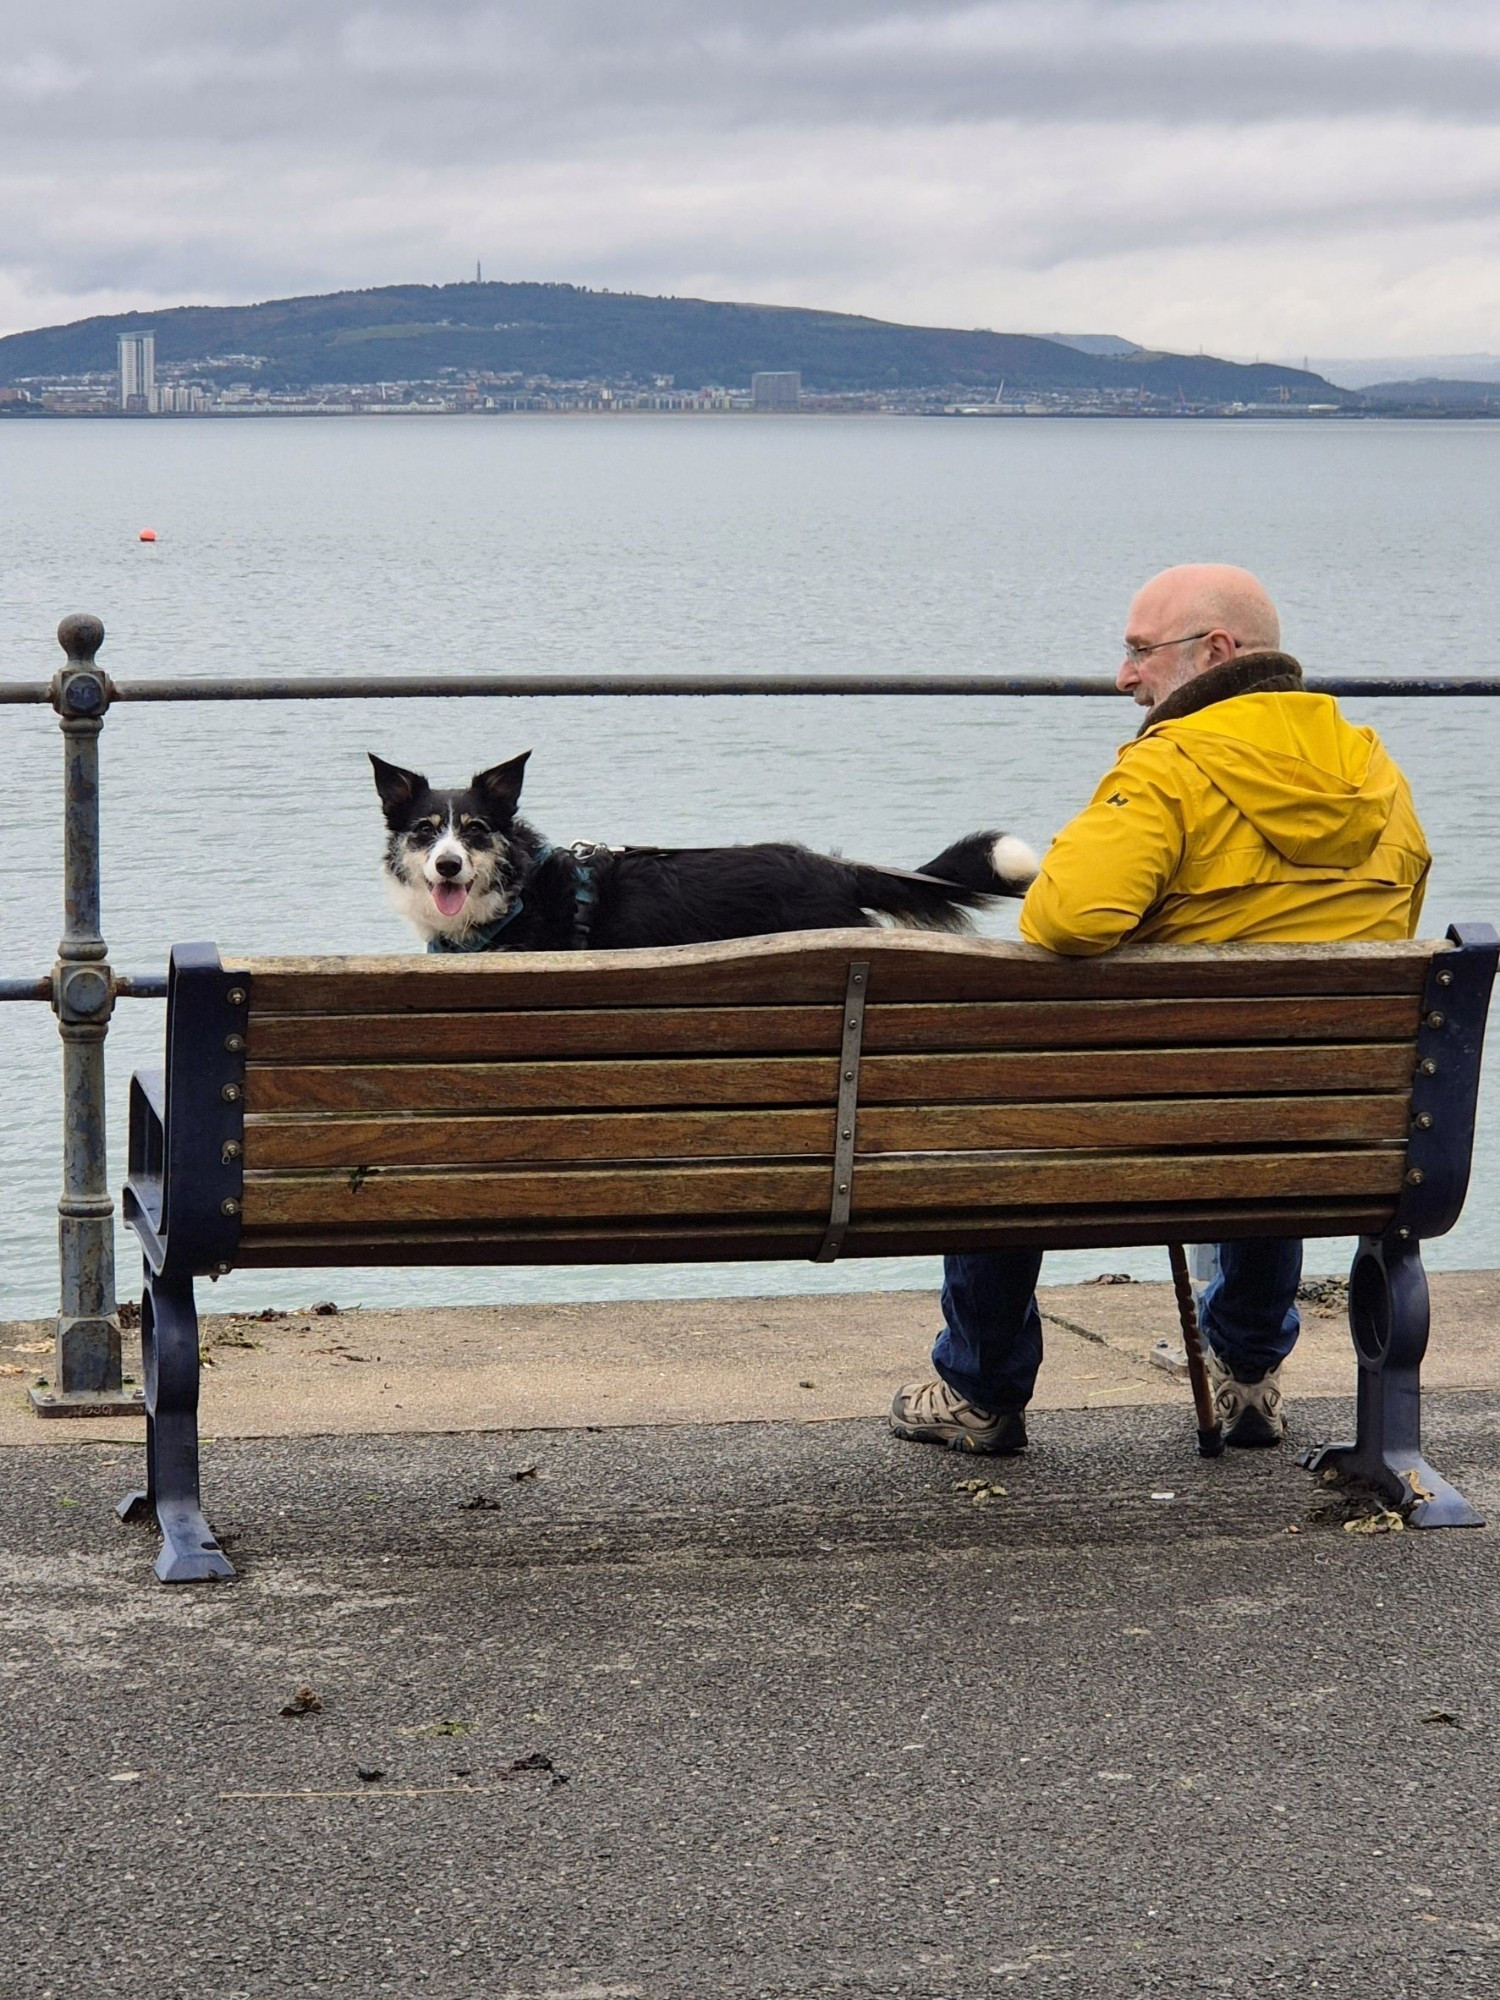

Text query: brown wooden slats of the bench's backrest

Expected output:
[209,932,1444,1264]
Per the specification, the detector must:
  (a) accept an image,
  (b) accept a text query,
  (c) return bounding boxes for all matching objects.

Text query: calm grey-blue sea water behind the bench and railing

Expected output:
[0,416,1500,1318]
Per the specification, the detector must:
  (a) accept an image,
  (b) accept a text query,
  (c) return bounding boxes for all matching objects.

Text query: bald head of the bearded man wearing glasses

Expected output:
[1116,562,1282,708]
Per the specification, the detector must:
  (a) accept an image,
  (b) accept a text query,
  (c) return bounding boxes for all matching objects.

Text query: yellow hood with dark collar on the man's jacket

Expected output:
[1144,654,1400,868]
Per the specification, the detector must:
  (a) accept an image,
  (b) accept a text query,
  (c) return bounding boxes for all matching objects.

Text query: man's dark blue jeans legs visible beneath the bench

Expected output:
[932,1238,1302,1410]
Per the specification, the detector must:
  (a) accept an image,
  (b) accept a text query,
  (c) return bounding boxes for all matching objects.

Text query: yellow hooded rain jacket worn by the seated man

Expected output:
[1020,654,1432,956]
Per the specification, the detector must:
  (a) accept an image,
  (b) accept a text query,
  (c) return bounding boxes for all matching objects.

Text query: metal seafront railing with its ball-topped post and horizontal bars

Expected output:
[0,614,1500,1416]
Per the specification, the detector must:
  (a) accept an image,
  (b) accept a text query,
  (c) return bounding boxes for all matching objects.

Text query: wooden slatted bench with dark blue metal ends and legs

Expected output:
[120,926,1500,1582]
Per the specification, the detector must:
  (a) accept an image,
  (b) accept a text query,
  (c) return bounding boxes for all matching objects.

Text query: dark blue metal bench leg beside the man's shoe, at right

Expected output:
[1300,1234,1484,1528]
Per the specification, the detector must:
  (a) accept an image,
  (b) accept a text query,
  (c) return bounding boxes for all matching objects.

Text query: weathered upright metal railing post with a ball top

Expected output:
[32,614,142,1416]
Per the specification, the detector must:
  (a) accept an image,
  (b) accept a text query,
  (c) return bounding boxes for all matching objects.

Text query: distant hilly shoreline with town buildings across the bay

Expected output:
[0,306,1500,420]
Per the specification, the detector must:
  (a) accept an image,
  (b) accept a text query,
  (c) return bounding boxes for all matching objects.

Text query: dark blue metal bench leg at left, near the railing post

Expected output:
[114,1270,234,1584]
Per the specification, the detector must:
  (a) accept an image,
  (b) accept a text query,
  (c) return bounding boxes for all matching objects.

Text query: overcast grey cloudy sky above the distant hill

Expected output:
[0,0,1500,358]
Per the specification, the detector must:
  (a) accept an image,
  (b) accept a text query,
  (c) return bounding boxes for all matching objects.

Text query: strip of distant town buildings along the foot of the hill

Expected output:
[0,332,1358,418]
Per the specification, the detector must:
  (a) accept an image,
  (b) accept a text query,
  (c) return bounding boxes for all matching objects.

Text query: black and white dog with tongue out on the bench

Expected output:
[370,750,1036,952]
